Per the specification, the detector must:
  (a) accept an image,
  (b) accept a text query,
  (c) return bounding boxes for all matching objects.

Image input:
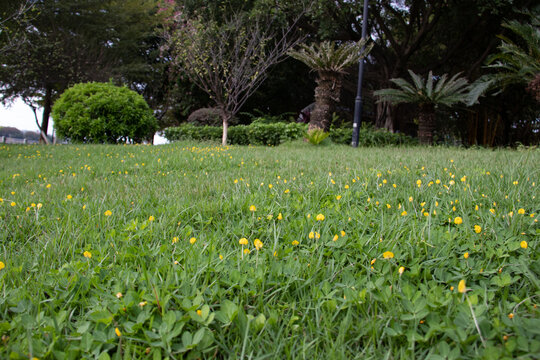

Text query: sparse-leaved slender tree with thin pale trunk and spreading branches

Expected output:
[164,2,300,145]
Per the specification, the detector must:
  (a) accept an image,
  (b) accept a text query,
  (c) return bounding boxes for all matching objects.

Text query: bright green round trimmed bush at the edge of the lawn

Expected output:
[52,82,157,143]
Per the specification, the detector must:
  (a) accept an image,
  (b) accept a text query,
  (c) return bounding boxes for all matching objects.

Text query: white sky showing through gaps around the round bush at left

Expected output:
[0,100,167,145]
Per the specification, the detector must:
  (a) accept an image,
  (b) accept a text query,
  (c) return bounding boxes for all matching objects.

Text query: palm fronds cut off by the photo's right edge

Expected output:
[487,17,540,102]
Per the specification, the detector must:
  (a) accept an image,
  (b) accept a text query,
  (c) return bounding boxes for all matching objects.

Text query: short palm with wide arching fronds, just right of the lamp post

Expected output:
[374,70,480,144]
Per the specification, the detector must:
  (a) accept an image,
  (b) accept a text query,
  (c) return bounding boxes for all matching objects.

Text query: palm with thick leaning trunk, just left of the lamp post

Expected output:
[289,39,373,131]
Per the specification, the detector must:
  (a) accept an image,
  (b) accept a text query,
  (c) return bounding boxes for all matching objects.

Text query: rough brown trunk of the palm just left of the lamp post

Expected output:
[308,71,342,131]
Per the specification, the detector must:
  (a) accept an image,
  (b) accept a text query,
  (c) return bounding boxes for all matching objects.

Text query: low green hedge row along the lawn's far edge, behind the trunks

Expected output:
[164,123,417,146]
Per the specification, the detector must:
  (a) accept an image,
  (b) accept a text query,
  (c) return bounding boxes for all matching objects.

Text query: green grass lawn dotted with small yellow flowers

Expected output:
[0,142,540,359]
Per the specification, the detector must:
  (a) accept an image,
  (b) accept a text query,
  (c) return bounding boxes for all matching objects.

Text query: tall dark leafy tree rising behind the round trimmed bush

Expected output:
[0,0,159,142]
